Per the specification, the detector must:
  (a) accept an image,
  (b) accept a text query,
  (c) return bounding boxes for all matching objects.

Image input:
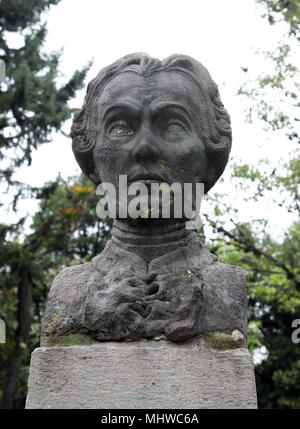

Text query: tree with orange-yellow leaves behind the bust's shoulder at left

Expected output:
[0,177,110,408]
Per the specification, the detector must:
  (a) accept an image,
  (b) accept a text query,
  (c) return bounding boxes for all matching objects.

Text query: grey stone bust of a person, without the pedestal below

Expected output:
[41,54,247,346]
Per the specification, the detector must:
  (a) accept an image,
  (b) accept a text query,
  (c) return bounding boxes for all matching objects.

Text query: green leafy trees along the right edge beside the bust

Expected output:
[205,0,300,408]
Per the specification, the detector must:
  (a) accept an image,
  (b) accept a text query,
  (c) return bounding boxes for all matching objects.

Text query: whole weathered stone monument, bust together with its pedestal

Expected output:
[27,54,256,408]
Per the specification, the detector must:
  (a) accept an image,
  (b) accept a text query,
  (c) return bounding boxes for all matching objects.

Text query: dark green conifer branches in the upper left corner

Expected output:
[0,0,89,182]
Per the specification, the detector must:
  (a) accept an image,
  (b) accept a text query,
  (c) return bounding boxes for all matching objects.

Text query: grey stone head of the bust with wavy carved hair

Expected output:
[71,53,231,201]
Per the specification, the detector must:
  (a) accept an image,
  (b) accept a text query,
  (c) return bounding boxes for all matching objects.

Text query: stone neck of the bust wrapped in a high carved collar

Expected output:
[112,220,193,263]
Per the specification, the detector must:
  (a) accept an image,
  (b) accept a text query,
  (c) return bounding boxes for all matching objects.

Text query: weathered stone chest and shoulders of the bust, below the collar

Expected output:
[41,233,247,346]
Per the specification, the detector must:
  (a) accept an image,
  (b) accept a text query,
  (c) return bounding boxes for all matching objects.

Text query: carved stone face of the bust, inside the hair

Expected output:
[94,71,208,221]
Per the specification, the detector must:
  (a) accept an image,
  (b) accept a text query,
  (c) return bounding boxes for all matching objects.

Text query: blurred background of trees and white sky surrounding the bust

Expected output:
[0,0,300,408]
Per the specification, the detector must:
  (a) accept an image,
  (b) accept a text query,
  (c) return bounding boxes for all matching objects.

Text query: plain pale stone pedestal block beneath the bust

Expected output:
[26,340,257,409]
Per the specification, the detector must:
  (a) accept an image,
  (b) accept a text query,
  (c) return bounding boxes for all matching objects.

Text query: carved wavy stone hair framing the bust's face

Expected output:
[71,53,232,192]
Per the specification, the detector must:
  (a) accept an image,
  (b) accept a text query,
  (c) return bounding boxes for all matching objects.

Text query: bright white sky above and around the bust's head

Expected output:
[3,0,298,234]
